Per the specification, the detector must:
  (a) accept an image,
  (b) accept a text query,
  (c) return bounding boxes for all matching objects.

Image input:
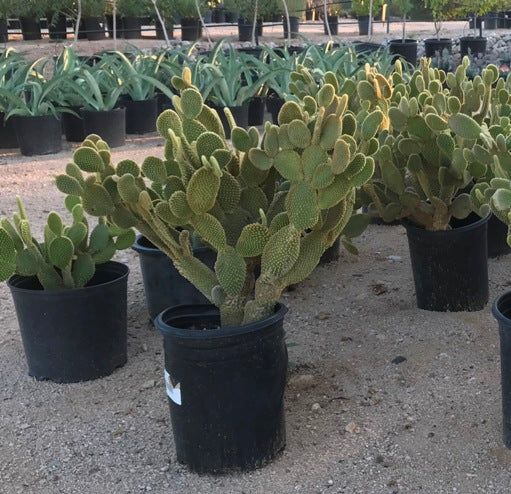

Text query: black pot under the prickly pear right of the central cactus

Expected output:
[403,214,490,312]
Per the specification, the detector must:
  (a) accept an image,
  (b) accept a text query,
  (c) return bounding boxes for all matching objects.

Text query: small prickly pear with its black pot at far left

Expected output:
[0,189,134,383]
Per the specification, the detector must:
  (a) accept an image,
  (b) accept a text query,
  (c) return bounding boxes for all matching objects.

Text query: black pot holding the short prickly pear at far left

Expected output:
[8,261,129,383]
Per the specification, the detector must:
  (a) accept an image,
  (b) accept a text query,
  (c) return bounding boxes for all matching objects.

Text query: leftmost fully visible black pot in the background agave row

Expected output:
[13,115,62,156]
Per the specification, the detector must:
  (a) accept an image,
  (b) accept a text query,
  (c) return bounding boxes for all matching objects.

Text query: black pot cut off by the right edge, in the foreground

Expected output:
[492,292,511,449]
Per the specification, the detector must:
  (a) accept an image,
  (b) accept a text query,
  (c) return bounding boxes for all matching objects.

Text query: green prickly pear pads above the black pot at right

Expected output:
[359,57,502,230]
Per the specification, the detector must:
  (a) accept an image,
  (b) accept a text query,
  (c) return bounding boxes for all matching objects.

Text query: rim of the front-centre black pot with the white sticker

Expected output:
[154,302,288,340]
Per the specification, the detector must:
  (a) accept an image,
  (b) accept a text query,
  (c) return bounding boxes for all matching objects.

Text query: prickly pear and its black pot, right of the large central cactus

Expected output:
[358,57,498,311]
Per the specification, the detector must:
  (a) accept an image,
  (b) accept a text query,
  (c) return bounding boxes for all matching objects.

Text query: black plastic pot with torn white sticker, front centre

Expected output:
[156,304,287,473]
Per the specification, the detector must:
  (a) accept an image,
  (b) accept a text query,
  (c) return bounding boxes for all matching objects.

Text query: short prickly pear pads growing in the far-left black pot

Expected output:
[0,194,135,290]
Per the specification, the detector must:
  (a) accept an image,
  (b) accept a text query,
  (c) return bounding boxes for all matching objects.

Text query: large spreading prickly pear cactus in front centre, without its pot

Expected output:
[56,69,383,326]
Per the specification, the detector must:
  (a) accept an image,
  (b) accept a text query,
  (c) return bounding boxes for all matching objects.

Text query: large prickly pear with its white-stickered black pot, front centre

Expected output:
[54,64,383,472]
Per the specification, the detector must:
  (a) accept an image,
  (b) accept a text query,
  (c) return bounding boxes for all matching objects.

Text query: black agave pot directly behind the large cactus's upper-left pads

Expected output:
[80,108,126,148]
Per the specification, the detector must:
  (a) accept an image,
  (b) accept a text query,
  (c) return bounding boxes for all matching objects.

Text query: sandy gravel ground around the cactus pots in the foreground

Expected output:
[0,25,511,494]
